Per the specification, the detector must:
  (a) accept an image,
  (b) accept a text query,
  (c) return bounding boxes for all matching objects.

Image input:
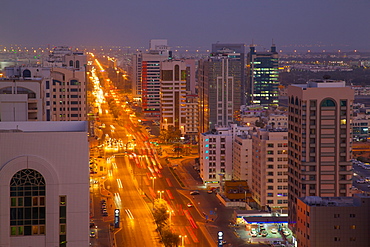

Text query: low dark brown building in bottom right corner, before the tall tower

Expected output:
[296,194,370,247]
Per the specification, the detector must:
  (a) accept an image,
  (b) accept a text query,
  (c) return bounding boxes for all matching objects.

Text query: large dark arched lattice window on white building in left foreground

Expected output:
[10,169,46,236]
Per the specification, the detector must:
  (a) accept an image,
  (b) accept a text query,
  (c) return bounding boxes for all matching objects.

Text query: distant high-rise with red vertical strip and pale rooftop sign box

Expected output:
[132,40,171,120]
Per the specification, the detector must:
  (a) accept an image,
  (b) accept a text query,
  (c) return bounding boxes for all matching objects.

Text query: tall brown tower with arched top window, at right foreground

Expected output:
[288,80,354,231]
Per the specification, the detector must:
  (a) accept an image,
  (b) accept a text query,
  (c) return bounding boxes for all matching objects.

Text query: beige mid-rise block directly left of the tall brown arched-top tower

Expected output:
[248,129,288,209]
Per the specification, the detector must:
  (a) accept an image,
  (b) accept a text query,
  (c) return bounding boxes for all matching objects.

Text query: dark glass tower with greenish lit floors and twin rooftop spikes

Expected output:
[246,45,279,106]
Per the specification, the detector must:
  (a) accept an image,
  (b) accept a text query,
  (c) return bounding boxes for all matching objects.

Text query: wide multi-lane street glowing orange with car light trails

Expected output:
[89,57,213,247]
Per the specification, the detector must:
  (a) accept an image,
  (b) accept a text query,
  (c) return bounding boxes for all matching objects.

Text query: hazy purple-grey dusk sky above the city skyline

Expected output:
[0,0,370,51]
